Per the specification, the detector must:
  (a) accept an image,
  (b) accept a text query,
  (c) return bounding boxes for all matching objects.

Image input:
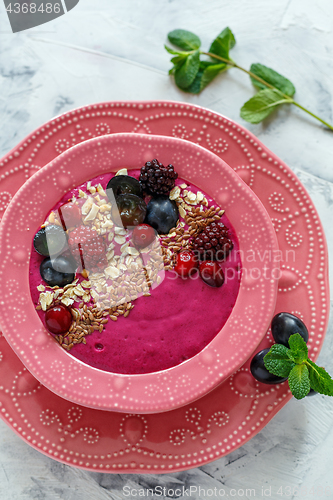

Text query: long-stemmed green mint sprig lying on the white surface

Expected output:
[165,27,333,130]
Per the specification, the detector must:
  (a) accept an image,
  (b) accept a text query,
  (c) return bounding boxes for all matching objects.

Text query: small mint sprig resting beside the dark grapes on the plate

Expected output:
[264,333,333,399]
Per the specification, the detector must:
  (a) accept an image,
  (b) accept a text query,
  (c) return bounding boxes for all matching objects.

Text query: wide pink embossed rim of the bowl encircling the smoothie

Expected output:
[0,134,279,413]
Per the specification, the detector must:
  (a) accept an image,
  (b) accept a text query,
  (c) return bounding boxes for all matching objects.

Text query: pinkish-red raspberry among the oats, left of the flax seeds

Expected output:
[68,226,107,272]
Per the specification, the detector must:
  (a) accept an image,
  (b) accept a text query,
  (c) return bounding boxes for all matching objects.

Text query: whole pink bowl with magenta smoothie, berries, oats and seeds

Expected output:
[0,134,279,413]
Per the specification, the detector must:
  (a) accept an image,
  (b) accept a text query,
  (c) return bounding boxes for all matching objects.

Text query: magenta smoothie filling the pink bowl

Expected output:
[30,171,241,374]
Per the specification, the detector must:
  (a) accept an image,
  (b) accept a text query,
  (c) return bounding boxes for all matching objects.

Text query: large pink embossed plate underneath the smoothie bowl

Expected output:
[0,102,329,473]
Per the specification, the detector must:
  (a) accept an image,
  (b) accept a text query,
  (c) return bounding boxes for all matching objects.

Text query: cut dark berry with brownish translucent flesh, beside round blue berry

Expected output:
[111,194,147,228]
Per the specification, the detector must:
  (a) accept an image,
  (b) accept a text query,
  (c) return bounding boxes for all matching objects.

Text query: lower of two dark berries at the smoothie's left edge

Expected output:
[39,255,77,287]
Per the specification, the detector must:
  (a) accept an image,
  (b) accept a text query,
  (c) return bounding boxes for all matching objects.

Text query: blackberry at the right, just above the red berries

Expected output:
[193,221,233,260]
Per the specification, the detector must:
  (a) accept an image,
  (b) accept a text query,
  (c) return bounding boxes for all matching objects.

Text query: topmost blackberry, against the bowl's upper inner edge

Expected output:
[139,159,178,195]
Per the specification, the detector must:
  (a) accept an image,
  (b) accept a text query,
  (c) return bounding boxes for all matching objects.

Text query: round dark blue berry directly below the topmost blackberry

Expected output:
[145,195,179,234]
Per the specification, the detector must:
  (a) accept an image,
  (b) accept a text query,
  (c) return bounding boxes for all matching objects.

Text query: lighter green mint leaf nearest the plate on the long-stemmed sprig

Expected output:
[240,89,292,123]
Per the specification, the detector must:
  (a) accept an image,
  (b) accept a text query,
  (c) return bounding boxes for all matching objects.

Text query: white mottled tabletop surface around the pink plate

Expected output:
[0,0,333,500]
